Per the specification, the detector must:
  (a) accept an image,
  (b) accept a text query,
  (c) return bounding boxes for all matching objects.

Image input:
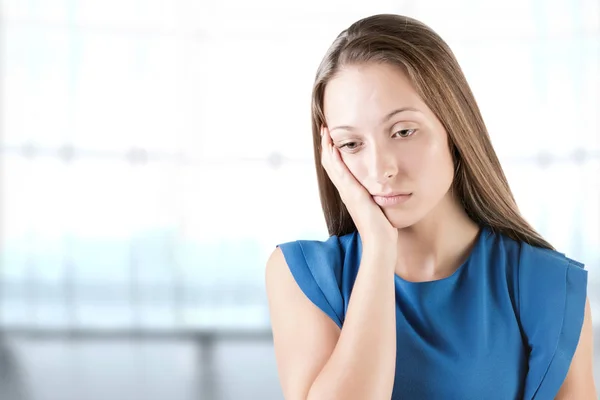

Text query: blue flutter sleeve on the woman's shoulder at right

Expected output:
[502,238,587,398]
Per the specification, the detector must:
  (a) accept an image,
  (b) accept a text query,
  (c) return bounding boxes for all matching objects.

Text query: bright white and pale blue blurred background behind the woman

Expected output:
[0,0,600,400]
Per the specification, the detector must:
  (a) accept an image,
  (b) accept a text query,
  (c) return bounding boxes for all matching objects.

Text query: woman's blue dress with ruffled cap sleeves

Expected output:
[278,227,587,400]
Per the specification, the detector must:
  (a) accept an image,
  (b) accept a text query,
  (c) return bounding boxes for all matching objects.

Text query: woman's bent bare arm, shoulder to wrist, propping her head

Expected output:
[266,248,396,400]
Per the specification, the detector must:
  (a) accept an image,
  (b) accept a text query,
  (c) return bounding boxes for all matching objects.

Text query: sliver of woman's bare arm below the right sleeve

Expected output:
[556,299,597,400]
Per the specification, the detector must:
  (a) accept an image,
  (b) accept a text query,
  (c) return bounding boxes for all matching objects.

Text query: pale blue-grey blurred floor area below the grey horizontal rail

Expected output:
[0,330,600,400]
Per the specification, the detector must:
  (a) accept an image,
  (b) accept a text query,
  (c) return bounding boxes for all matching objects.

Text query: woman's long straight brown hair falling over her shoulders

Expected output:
[312,14,553,249]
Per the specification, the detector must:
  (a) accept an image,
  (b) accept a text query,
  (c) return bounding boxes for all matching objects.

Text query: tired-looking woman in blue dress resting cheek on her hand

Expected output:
[266,15,596,400]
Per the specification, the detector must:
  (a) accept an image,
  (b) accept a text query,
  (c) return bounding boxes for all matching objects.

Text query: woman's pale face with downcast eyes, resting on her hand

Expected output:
[324,64,454,228]
